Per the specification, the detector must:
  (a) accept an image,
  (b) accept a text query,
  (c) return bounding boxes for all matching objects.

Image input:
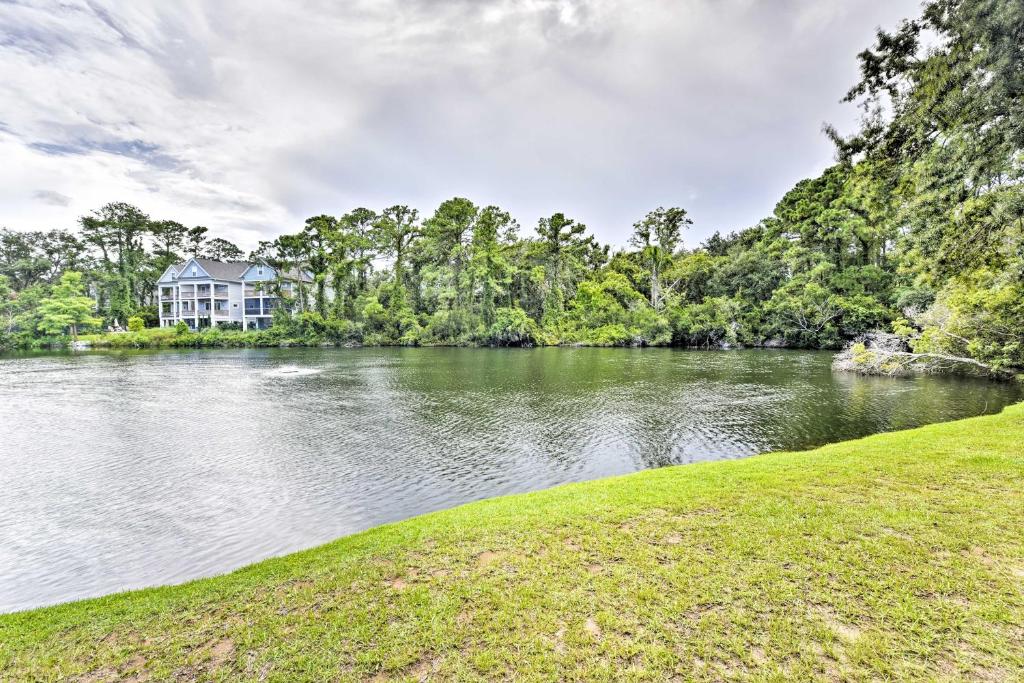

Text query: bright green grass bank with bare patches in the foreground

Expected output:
[0,405,1024,681]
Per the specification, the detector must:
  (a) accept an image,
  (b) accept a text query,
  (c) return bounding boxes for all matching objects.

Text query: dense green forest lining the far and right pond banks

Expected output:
[0,0,1024,371]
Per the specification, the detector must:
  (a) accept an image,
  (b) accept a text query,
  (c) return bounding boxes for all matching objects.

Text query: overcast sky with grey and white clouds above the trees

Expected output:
[0,0,920,250]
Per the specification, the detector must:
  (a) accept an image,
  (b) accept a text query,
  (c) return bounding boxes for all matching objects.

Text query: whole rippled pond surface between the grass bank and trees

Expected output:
[0,349,1020,610]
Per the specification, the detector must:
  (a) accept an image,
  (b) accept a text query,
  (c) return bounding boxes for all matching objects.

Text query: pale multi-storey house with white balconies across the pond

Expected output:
[157,258,312,330]
